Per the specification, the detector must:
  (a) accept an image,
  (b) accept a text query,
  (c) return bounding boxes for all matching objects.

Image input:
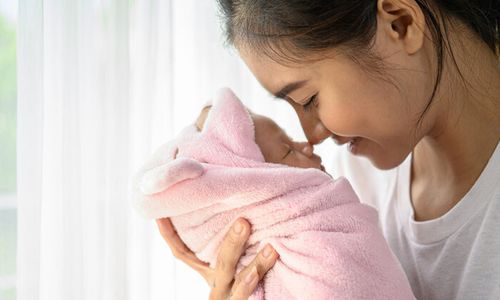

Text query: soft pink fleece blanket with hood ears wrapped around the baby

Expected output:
[133,89,414,299]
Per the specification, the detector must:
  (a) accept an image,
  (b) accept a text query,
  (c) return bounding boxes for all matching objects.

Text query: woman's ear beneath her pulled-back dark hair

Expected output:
[377,0,425,54]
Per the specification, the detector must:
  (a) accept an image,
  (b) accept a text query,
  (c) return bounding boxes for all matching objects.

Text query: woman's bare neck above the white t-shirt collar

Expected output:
[411,27,500,221]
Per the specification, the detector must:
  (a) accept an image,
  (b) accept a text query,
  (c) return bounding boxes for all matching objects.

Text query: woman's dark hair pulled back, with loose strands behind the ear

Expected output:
[218,0,500,125]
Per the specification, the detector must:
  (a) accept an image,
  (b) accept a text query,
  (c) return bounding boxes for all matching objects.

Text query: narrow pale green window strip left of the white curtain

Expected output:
[0,0,17,300]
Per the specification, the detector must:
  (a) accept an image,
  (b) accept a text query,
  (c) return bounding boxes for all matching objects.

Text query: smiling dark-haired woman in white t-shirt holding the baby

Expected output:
[154,0,500,299]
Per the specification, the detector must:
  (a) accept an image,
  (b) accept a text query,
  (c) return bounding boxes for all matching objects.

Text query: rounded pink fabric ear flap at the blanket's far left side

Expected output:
[139,157,204,195]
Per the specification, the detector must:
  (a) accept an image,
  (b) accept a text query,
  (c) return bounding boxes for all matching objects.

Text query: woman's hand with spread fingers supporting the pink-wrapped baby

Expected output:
[156,218,278,300]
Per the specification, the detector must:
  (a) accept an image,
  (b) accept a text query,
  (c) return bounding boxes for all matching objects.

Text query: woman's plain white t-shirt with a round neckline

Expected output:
[333,143,500,300]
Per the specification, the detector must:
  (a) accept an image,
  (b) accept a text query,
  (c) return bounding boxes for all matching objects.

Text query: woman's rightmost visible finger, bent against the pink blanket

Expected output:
[231,244,279,299]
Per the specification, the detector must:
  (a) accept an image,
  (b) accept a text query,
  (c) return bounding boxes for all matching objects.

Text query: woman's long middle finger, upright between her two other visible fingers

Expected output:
[210,219,250,299]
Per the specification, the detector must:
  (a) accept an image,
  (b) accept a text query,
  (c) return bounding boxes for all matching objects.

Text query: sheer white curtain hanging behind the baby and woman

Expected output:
[17,0,328,300]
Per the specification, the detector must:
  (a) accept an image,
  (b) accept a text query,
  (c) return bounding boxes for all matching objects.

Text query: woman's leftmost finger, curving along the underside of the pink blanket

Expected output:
[156,218,213,283]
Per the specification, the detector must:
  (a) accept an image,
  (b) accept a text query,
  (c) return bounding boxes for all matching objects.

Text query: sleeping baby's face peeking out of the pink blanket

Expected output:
[252,114,325,171]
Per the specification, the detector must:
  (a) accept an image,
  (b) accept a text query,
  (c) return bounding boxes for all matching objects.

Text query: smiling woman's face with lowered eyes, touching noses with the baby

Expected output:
[238,19,436,169]
